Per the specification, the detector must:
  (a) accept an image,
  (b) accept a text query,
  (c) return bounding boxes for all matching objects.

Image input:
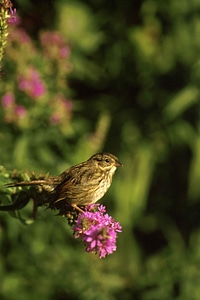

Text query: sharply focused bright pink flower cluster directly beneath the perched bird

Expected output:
[73,204,122,258]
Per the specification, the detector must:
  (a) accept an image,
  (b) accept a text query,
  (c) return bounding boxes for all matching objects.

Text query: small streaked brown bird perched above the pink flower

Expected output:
[7,152,122,211]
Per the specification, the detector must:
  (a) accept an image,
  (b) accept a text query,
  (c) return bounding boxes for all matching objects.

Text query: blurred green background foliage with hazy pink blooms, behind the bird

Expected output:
[0,0,200,300]
